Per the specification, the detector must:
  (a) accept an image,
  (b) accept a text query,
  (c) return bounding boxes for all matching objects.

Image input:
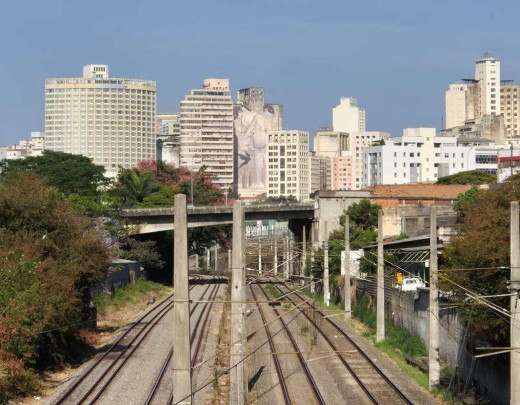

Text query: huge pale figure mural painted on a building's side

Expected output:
[234,87,282,198]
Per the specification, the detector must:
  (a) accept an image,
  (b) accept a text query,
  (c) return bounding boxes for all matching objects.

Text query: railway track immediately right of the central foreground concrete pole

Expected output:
[250,285,326,404]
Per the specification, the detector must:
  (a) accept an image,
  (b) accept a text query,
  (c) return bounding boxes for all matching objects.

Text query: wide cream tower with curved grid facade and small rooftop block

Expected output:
[45,65,157,177]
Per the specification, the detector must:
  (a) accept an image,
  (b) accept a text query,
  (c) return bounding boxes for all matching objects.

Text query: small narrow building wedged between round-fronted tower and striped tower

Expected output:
[155,113,180,167]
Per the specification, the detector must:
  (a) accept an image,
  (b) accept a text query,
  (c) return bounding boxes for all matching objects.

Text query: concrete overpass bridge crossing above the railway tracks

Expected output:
[121,202,316,235]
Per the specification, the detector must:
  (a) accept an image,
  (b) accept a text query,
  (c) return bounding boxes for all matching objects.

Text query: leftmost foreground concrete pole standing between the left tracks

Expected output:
[173,194,192,404]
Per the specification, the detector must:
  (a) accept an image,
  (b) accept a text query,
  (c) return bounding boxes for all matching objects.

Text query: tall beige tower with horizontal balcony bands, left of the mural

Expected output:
[179,79,234,190]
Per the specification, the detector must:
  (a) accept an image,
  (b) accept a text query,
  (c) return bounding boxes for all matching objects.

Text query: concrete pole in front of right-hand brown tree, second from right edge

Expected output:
[428,205,441,389]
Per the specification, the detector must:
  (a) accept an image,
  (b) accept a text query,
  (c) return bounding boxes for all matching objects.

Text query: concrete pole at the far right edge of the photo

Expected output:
[509,201,520,404]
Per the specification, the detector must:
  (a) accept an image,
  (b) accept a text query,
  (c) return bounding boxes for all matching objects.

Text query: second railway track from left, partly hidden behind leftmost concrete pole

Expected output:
[144,284,219,405]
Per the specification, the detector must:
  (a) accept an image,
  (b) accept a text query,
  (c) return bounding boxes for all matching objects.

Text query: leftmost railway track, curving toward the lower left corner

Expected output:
[54,286,210,405]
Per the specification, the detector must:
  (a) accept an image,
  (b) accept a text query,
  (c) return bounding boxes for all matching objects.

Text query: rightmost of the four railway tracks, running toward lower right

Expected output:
[276,285,413,405]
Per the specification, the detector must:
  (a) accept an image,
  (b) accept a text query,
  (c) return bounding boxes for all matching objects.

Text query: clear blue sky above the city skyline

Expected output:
[0,0,520,144]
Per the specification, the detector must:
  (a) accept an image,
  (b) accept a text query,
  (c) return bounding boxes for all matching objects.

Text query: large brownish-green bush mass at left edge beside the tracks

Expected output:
[0,173,109,402]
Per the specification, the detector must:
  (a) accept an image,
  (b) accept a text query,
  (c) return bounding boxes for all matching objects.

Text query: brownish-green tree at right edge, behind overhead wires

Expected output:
[443,175,520,344]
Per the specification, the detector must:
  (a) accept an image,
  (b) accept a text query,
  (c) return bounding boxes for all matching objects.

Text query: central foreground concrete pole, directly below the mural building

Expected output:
[229,201,245,405]
